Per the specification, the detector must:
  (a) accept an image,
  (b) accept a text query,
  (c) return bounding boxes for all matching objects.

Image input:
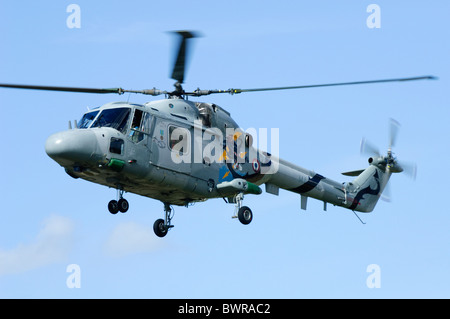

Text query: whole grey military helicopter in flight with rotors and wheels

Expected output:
[0,31,436,237]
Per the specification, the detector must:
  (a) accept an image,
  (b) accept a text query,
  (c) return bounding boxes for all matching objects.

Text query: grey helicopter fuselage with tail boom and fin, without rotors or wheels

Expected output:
[45,98,391,212]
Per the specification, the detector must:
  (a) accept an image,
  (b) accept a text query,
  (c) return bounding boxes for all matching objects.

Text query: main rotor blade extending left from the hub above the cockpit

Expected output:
[0,83,167,96]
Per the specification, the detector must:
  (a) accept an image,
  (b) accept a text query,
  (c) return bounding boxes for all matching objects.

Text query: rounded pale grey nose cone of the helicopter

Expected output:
[45,129,98,166]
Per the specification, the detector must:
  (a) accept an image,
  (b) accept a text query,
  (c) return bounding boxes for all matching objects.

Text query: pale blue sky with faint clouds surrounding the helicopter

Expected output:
[0,0,450,298]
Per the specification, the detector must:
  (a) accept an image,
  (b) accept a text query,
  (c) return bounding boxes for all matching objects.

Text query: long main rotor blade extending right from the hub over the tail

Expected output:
[186,75,437,96]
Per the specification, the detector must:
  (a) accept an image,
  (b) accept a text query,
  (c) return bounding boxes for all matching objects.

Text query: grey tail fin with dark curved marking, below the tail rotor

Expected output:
[346,163,392,213]
